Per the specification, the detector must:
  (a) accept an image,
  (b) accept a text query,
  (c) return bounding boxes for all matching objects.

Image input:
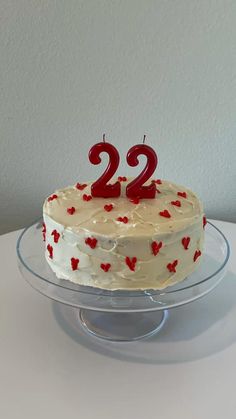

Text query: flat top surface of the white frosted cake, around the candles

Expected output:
[43,177,203,237]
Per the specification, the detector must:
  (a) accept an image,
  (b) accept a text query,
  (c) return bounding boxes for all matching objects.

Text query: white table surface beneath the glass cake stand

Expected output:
[0,221,236,419]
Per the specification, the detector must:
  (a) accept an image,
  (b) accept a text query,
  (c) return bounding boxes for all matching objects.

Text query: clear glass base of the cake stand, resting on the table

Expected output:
[79,309,168,342]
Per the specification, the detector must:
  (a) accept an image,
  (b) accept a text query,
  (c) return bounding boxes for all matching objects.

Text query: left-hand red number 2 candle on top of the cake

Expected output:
[89,135,120,198]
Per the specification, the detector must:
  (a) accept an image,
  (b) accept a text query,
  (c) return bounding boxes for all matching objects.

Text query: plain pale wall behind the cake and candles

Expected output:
[0,0,236,233]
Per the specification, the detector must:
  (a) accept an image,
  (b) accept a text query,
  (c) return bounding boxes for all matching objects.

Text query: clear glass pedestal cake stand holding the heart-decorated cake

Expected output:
[17,220,230,341]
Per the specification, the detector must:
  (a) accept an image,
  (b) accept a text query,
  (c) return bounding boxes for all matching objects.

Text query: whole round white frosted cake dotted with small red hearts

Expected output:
[43,177,206,290]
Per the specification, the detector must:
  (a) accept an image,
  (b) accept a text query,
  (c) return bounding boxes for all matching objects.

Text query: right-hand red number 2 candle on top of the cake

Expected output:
[126,136,158,199]
